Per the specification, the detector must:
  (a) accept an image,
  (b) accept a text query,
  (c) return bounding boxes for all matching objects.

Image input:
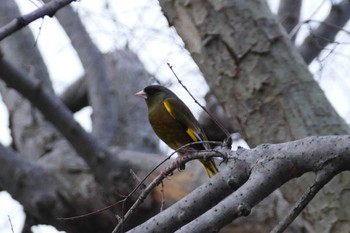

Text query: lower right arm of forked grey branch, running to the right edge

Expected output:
[179,136,350,232]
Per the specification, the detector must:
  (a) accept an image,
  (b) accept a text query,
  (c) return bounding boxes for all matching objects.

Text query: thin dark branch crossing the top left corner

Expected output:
[0,0,75,41]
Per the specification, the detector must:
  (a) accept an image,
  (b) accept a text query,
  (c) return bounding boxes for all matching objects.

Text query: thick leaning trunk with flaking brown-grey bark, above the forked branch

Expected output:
[160,0,349,232]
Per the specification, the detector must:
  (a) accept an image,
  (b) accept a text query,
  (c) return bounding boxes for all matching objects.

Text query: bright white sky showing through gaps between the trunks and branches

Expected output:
[0,0,350,233]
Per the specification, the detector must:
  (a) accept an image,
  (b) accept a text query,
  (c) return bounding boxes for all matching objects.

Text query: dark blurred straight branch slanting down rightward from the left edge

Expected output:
[0,59,128,187]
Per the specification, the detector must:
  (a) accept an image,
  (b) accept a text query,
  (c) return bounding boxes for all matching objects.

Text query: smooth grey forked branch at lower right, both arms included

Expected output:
[129,136,350,233]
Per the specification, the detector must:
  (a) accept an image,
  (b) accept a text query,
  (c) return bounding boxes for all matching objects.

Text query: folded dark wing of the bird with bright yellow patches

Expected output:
[163,98,209,149]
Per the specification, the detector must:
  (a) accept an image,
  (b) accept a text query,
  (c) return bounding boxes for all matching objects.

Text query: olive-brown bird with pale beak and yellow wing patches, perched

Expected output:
[135,85,219,177]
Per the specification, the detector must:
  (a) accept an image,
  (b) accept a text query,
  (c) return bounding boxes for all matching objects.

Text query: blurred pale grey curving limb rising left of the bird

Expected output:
[42,0,118,145]
